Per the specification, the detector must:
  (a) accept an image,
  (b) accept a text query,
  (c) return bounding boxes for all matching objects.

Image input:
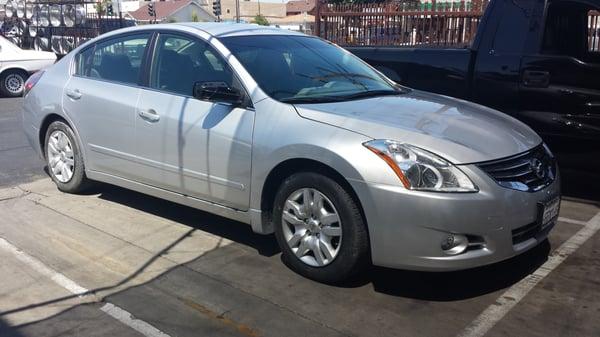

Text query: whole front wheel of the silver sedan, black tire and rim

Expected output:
[273,172,370,283]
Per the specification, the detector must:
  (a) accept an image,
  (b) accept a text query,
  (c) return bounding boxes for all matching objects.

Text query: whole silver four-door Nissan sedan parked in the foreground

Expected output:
[23,23,560,282]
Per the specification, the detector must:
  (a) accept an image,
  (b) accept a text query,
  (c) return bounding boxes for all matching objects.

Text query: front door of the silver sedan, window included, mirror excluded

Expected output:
[135,33,254,210]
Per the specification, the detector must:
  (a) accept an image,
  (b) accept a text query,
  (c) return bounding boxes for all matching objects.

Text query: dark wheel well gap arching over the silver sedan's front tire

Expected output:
[260,158,367,228]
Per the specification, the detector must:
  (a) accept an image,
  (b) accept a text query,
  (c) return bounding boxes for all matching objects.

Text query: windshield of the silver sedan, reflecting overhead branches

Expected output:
[221,35,401,103]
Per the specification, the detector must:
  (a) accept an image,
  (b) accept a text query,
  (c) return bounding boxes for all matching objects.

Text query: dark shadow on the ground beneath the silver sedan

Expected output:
[90,184,550,301]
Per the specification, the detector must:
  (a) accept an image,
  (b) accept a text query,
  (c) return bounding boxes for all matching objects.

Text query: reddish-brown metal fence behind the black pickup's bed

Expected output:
[315,0,489,47]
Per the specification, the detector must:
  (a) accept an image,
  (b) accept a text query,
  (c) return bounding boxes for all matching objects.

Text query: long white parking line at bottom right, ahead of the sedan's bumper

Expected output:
[458,213,600,337]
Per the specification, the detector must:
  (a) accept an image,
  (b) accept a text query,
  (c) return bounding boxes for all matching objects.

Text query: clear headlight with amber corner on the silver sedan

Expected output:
[363,139,478,192]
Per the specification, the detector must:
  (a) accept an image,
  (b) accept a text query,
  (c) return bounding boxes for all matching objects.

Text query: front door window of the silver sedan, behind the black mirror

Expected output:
[150,34,236,96]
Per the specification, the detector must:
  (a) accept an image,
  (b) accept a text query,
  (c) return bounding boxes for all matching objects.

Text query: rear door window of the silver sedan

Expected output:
[75,33,150,84]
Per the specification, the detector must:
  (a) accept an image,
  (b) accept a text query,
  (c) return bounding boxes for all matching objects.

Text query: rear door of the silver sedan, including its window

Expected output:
[63,32,151,179]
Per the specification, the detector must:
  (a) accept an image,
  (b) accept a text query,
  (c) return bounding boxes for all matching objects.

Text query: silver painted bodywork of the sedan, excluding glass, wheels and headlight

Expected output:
[23,23,560,270]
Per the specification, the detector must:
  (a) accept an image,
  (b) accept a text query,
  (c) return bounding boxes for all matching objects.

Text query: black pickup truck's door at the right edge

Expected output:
[519,1,600,172]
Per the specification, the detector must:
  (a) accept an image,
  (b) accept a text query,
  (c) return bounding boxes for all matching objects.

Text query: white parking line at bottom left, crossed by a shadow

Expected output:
[0,238,169,337]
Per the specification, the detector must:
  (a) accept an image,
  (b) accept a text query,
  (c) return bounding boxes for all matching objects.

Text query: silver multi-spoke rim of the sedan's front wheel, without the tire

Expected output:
[281,188,342,267]
